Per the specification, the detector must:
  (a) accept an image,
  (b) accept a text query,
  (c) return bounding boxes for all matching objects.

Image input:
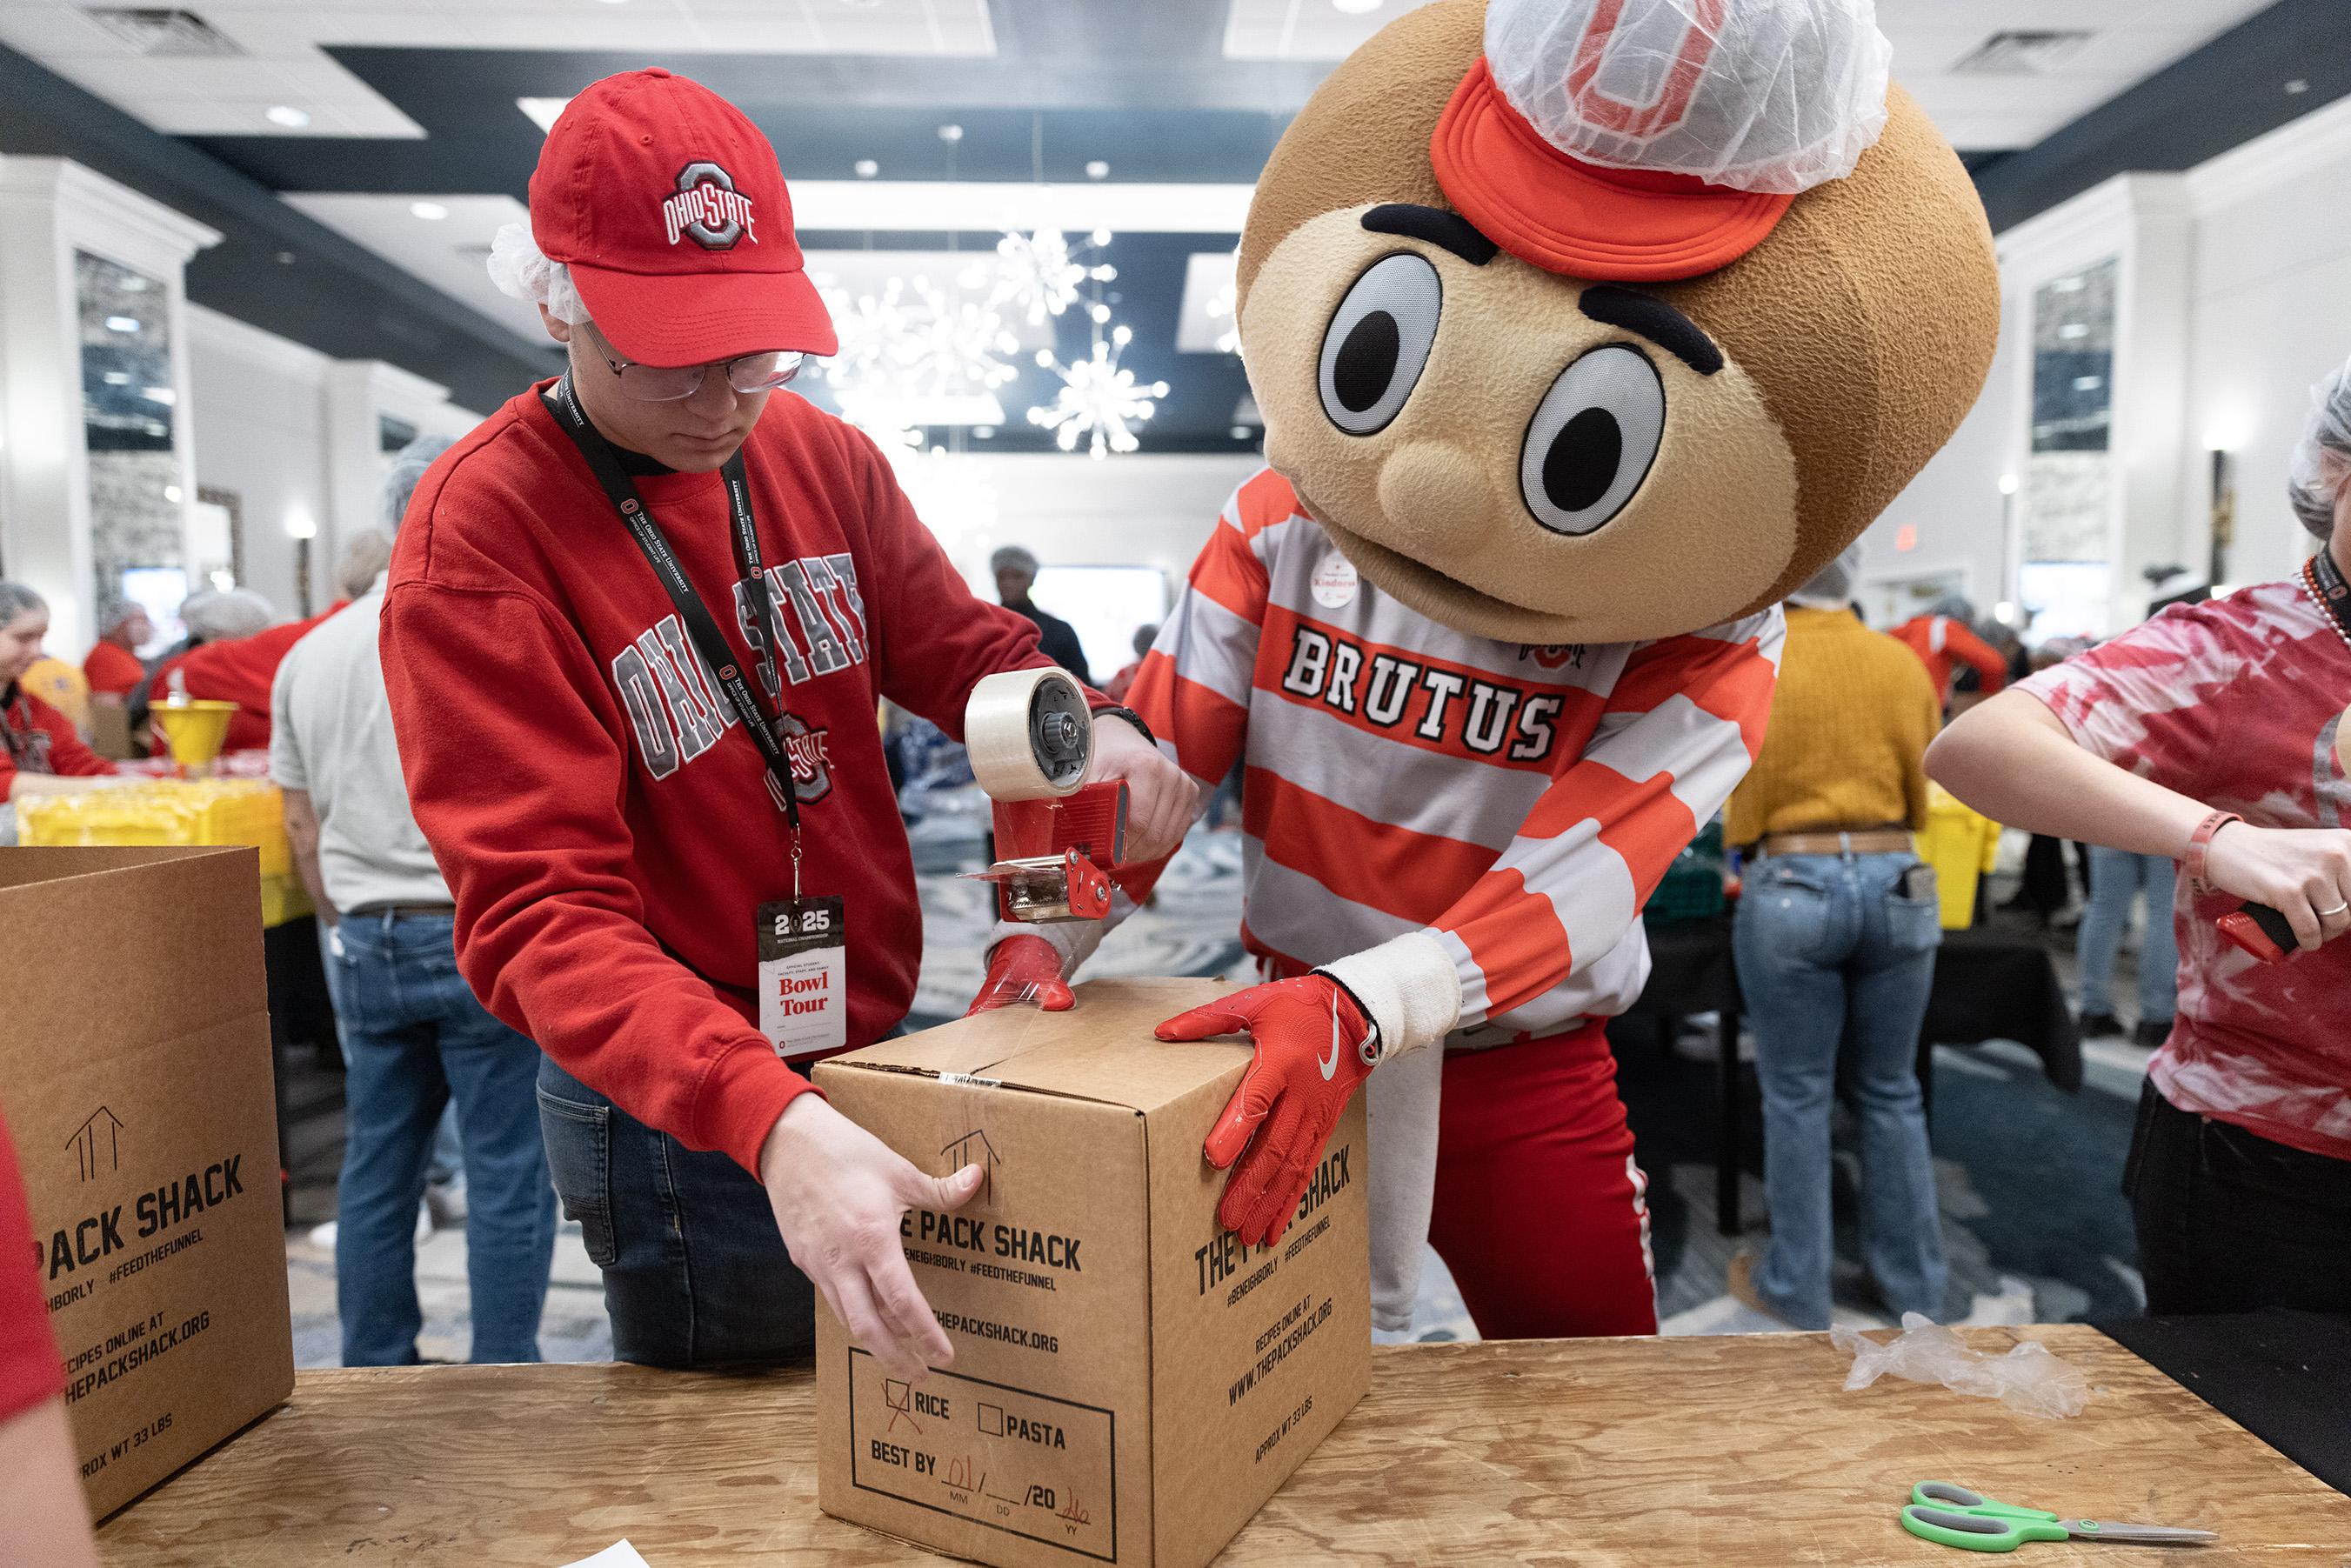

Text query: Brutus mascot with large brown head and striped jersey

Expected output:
[980,0,1999,1338]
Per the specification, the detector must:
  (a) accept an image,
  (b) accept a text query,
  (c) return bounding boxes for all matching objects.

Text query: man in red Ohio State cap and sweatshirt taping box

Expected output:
[384,70,1194,1375]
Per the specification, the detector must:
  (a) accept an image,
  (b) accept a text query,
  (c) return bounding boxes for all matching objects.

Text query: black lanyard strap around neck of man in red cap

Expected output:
[555,377,799,878]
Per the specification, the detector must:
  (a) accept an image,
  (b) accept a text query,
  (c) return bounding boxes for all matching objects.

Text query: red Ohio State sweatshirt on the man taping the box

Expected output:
[384,388,1062,1171]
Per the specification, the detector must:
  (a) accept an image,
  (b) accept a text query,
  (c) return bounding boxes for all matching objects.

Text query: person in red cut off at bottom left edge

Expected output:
[0,1121,99,1568]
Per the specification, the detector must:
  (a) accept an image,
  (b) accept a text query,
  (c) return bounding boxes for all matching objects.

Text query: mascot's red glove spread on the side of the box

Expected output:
[1159,973,1380,1246]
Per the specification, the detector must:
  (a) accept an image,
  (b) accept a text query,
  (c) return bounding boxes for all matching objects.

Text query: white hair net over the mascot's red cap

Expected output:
[1486,0,1893,193]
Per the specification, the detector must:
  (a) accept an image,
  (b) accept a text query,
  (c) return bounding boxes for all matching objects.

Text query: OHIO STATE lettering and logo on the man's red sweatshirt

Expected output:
[611,552,867,809]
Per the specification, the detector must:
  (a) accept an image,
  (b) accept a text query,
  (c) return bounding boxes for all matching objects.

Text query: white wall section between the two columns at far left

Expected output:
[188,305,334,618]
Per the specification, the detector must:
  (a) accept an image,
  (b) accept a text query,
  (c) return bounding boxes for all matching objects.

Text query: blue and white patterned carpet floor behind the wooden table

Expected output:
[287,820,2147,1366]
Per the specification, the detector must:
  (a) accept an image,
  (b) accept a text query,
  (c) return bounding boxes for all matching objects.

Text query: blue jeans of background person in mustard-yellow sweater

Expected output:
[1733,853,1949,1328]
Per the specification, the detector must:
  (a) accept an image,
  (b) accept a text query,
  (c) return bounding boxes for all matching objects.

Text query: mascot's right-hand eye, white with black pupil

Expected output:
[1519,344,1665,534]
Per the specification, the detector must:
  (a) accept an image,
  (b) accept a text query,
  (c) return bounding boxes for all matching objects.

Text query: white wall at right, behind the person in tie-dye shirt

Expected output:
[1862,99,2351,630]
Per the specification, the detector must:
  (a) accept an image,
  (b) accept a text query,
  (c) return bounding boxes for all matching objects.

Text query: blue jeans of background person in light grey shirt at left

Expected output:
[334,915,555,1366]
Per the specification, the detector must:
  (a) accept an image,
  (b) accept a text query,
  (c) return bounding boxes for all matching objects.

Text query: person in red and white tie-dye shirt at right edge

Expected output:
[1927,352,2351,1311]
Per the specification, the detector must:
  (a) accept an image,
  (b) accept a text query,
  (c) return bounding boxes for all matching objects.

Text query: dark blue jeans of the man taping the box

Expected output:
[538,1060,816,1366]
